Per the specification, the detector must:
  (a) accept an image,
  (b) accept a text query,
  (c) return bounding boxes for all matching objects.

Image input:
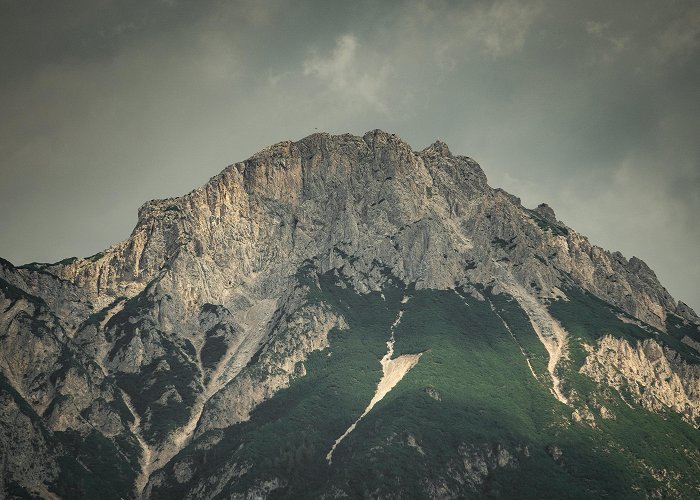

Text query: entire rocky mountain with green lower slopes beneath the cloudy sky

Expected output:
[0,130,700,500]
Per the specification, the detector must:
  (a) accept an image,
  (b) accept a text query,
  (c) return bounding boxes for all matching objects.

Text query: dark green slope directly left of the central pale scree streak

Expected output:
[153,265,401,497]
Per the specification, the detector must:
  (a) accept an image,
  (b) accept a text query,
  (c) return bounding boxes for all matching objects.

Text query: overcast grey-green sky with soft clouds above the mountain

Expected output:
[0,0,700,312]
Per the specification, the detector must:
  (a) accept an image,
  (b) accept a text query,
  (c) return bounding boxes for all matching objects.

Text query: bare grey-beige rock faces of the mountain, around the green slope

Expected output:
[0,130,700,497]
